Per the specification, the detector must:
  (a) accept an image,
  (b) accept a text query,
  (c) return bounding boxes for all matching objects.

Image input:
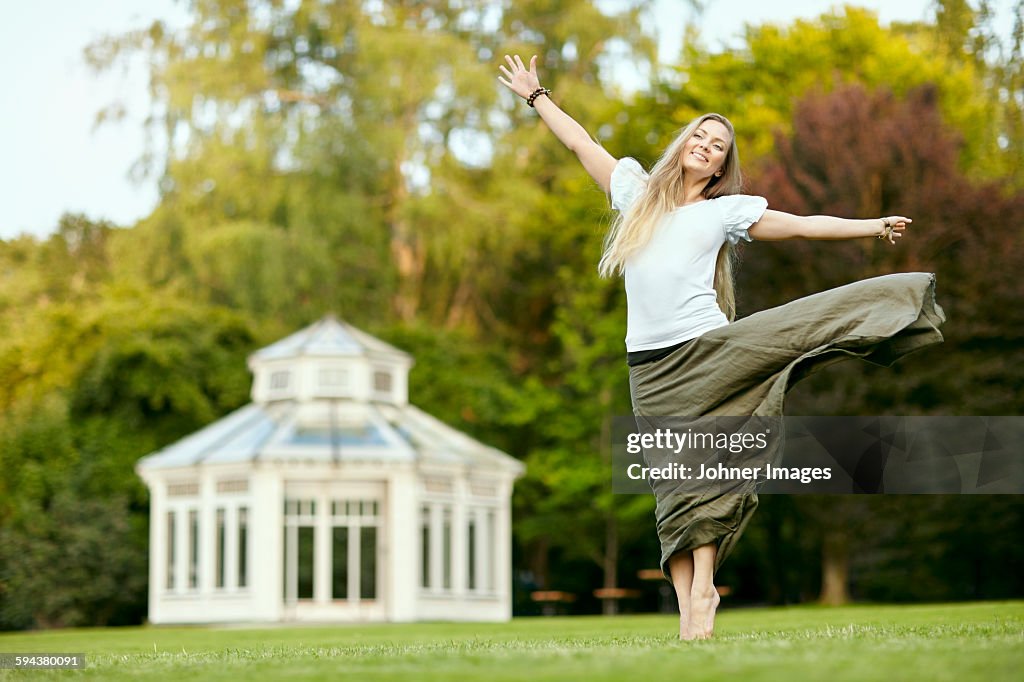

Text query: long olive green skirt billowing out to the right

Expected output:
[630,272,945,580]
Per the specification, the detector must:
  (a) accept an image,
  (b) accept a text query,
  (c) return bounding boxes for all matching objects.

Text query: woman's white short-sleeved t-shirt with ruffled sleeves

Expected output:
[609,157,768,352]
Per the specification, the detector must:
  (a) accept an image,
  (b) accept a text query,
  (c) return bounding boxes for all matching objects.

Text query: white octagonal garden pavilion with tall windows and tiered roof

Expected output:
[136,316,524,624]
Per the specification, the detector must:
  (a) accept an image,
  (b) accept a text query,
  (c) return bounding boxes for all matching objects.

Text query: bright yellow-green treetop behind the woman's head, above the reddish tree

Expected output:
[609,6,1010,178]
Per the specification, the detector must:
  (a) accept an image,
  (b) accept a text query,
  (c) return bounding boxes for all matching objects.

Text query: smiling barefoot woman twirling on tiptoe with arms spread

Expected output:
[499,55,944,639]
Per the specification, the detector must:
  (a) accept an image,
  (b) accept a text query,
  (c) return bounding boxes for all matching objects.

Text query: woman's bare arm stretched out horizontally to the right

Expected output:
[748,210,913,244]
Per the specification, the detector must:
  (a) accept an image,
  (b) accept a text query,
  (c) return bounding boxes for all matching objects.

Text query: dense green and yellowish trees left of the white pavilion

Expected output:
[0,289,255,628]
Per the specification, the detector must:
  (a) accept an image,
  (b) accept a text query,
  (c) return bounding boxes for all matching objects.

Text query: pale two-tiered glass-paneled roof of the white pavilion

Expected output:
[137,315,523,474]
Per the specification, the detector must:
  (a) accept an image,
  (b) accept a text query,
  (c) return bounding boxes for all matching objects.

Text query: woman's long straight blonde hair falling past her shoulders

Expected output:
[597,114,742,321]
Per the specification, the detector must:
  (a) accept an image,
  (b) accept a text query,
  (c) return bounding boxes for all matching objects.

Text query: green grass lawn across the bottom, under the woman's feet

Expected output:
[0,601,1024,682]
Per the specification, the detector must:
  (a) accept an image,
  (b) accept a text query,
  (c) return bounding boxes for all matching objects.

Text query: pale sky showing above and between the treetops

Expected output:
[0,0,966,240]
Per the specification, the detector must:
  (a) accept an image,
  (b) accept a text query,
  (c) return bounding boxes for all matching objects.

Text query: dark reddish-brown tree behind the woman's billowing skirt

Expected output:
[740,80,1024,603]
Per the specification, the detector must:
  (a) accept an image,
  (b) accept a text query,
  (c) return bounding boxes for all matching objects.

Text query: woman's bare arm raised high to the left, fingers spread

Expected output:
[498,54,618,194]
